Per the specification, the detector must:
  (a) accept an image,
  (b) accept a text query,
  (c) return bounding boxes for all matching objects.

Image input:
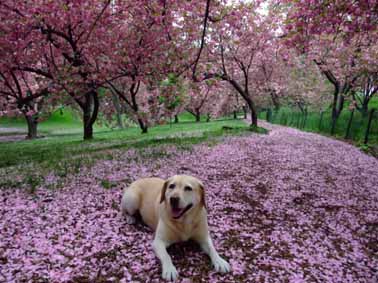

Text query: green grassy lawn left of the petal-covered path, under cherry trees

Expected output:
[0,111,264,191]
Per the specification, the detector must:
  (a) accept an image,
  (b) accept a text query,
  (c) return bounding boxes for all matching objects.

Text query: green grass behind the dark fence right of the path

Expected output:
[259,107,378,145]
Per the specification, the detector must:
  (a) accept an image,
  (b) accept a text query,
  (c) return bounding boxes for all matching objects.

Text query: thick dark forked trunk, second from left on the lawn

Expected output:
[83,90,99,140]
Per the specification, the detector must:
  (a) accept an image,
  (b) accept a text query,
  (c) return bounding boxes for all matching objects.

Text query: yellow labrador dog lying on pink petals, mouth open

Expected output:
[121,175,231,280]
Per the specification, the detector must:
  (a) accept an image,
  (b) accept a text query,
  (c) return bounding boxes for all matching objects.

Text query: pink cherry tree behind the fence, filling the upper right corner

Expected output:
[280,0,378,132]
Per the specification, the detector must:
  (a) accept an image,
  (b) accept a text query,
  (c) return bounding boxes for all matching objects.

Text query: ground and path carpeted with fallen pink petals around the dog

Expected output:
[0,125,378,283]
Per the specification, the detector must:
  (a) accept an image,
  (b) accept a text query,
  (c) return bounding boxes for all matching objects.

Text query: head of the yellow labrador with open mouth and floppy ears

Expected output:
[160,175,206,219]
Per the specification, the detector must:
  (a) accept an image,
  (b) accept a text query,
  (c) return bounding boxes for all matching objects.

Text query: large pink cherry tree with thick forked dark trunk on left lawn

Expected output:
[0,0,119,139]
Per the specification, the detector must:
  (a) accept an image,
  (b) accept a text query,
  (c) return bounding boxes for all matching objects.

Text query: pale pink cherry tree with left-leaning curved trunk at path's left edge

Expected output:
[203,3,273,126]
